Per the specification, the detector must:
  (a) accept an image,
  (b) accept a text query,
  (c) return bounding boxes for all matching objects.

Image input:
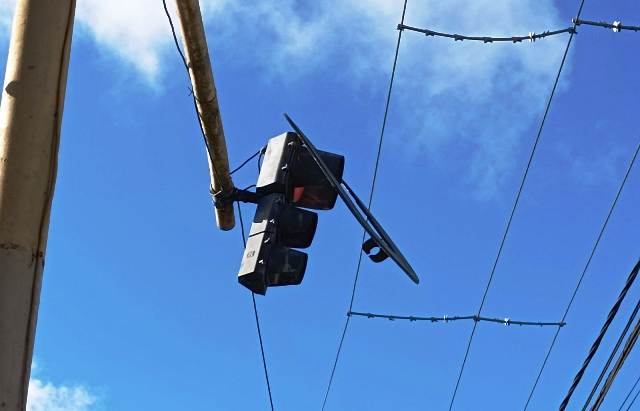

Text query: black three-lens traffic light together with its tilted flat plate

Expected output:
[235,114,420,295]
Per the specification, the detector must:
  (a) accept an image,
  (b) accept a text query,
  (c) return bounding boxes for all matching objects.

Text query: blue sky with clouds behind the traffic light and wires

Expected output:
[0,0,640,411]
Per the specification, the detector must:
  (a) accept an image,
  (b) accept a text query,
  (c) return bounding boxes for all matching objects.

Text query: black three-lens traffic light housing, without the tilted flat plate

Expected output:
[238,133,344,295]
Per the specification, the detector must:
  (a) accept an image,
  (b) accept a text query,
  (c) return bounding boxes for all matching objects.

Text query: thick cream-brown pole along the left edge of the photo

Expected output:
[0,0,76,411]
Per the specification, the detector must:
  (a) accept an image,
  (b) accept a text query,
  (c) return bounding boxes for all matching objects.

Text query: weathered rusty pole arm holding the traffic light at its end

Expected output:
[176,0,235,230]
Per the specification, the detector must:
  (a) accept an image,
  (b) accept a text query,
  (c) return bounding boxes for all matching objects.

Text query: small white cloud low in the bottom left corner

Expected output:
[27,379,96,411]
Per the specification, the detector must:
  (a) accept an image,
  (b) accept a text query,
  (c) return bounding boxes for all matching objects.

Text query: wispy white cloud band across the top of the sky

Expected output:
[0,0,568,197]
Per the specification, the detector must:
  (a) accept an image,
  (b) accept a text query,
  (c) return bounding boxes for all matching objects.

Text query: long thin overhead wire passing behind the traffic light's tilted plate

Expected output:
[322,0,408,411]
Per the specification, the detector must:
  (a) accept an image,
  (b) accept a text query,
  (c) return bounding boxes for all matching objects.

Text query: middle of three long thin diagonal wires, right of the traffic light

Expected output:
[449,0,585,411]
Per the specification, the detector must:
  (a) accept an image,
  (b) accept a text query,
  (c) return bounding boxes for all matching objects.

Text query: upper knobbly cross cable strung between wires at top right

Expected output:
[398,19,640,43]
